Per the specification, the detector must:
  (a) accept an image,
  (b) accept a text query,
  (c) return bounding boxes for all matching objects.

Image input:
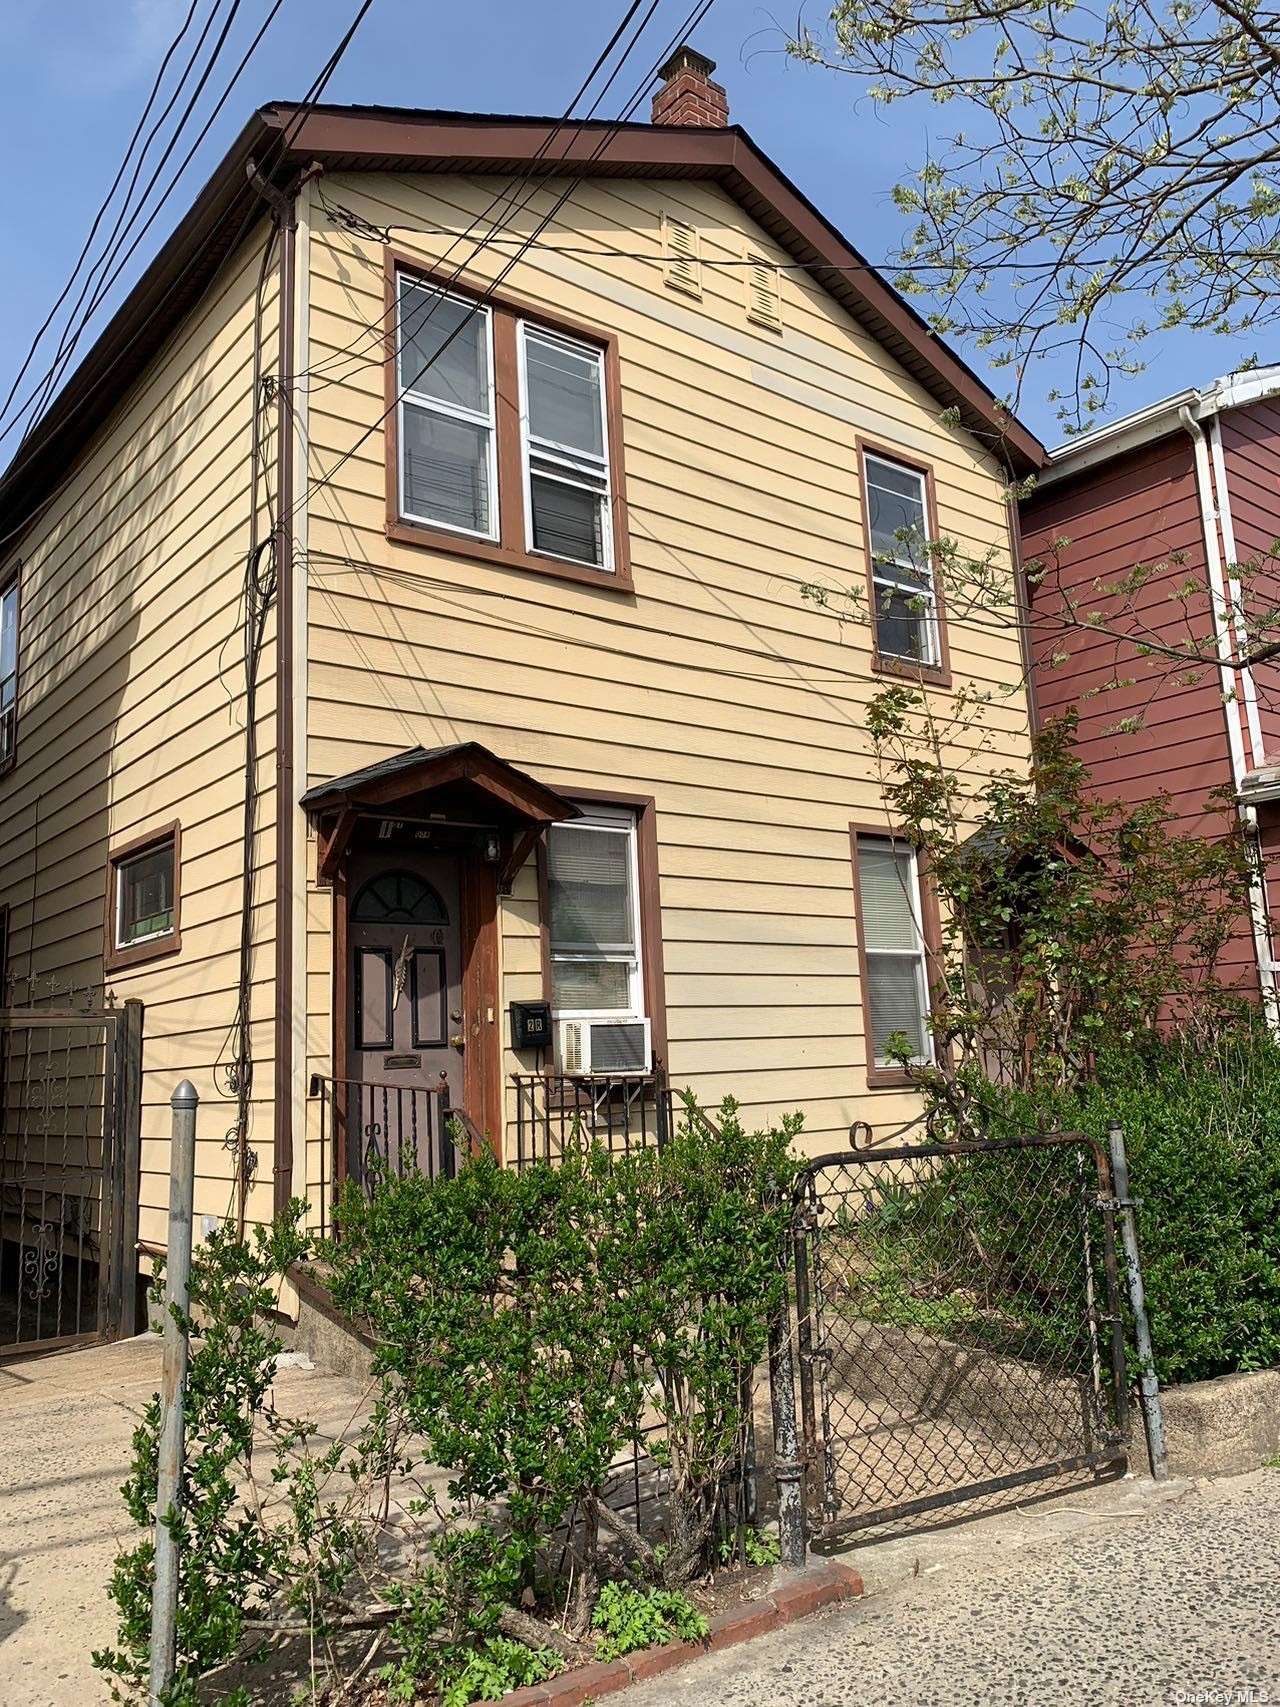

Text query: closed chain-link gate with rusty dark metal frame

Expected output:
[795,1133,1125,1538]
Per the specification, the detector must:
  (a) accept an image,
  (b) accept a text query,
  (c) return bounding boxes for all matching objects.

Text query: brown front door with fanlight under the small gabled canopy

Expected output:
[346,850,464,1180]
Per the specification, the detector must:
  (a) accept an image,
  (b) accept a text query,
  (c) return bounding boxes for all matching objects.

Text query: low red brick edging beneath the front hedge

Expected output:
[502,1560,864,1707]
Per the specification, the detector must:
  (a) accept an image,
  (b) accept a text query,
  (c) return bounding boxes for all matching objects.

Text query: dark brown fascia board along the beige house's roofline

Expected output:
[0,102,1044,534]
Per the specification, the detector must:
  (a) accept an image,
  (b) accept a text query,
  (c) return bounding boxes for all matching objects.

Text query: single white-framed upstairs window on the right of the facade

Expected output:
[864,451,942,667]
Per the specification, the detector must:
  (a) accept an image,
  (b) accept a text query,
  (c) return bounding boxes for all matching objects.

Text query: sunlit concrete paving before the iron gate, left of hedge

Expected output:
[0,1335,364,1707]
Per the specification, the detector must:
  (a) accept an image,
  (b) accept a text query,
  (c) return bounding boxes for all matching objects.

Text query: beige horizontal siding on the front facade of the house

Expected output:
[307,174,1027,1147]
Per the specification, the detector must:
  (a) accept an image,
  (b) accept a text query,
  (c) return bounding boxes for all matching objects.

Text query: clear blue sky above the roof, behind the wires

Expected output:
[0,0,1273,463]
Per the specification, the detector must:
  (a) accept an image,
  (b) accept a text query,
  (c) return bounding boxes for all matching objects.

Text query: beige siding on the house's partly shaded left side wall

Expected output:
[0,227,276,1244]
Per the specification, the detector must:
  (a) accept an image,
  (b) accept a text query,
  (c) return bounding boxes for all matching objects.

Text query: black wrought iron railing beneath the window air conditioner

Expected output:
[509,1069,672,1168]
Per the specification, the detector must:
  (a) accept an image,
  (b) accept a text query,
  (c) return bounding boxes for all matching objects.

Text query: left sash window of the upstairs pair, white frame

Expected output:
[396,273,498,539]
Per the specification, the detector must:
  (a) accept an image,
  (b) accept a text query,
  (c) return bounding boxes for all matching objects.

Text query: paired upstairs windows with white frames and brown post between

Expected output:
[391,268,630,587]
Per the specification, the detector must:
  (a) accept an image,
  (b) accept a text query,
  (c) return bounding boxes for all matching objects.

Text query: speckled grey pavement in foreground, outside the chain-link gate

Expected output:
[638,1470,1280,1707]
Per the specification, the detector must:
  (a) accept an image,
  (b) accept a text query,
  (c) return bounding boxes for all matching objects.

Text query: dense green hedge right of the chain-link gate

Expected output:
[942,1026,1280,1383]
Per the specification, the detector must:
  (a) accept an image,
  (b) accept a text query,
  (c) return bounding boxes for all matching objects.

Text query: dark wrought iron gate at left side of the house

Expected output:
[0,1002,142,1357]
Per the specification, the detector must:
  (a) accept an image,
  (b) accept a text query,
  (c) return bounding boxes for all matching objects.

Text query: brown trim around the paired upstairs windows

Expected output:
[382,248,633,592]
